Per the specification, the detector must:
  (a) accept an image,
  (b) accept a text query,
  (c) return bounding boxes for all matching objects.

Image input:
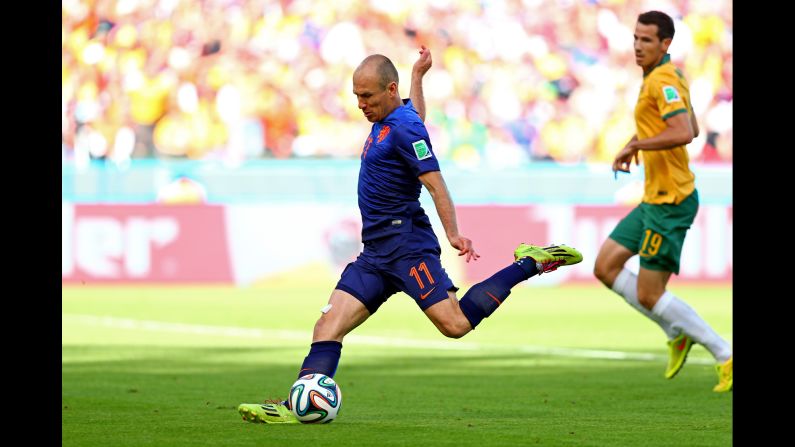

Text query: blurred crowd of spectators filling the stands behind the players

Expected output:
[62,0,733,167]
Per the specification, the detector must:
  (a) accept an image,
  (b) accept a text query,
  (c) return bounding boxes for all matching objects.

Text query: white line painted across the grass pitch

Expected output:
[61,314,715,365]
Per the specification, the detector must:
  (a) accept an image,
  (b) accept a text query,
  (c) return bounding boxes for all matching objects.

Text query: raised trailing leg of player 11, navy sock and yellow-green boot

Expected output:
[420,244,582,338]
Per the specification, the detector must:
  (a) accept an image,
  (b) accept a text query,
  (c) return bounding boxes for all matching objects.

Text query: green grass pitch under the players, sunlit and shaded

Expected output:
[61,280,732,447]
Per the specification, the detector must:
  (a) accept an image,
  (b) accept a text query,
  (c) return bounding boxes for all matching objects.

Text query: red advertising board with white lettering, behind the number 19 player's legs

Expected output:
[456,205,732,282]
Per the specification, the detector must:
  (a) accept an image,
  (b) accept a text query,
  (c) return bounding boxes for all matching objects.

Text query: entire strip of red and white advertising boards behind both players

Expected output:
[62,203,733,285]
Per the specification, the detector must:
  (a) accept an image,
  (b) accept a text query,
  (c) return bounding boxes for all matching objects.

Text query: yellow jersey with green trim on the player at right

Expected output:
[635,54,696,205]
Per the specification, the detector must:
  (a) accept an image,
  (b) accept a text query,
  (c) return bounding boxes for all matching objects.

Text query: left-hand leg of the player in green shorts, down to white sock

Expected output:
[594,207,679,341]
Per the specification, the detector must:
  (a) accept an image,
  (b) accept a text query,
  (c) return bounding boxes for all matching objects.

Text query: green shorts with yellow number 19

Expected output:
[610,190,698,275]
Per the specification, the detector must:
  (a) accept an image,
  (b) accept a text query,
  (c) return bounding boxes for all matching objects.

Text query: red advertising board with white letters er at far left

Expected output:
[62,203,233,283]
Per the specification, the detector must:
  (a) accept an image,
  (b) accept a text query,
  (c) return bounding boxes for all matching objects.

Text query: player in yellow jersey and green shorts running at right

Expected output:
[594,11,733,392]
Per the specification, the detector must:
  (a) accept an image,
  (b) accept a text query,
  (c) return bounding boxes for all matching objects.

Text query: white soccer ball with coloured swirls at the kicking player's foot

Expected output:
[290,374,342,424]
